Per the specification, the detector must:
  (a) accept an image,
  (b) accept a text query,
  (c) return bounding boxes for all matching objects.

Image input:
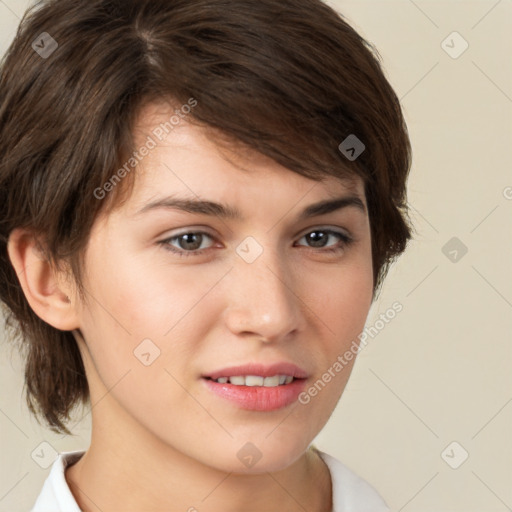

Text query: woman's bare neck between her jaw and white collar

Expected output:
[66,422,332,512]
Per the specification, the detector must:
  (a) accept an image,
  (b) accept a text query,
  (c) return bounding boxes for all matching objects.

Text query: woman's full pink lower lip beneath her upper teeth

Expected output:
[203,378,306,411]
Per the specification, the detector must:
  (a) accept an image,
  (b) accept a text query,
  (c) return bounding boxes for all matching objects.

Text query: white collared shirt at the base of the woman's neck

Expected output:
[30,450,389,512]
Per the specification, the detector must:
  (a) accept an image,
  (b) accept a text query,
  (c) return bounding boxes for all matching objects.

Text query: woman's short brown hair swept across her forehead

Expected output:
[0,0,412,434]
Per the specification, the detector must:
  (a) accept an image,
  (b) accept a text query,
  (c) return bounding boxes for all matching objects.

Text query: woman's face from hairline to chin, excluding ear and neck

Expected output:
[72,105,373,473]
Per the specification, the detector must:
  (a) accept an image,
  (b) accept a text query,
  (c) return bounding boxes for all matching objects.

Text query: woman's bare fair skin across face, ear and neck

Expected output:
[9,104,373,512]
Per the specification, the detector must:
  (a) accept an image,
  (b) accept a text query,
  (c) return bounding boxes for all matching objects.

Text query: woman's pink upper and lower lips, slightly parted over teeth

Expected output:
[201,362,308,412]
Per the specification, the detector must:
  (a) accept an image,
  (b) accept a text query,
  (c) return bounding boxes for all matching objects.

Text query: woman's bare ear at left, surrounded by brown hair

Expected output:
[7,228,79,331]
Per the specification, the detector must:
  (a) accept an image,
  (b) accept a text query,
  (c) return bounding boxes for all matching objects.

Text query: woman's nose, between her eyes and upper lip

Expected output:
[224,243,304,342]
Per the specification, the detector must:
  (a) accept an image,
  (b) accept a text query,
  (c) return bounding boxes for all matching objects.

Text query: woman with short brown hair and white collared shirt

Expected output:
[0,0,411,512]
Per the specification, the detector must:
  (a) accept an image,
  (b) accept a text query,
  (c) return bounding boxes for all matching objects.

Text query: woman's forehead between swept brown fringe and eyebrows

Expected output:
[133,102,364,204]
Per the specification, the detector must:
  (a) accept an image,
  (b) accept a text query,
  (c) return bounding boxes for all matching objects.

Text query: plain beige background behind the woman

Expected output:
[0,0,512,512]
